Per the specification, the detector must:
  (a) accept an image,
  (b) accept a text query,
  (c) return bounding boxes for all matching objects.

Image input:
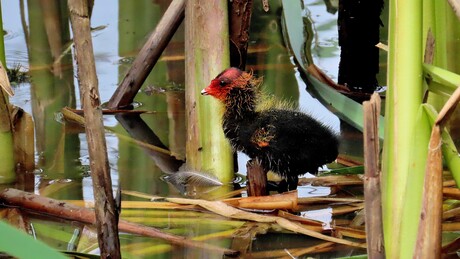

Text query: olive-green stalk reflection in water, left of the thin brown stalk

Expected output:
[28,1,82,199]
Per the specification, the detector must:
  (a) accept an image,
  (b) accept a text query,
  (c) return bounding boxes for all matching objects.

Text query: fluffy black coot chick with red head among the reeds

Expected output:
[201,67,339,190]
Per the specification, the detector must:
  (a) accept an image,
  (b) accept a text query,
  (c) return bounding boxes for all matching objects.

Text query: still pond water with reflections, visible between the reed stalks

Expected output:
[2,0,368,258]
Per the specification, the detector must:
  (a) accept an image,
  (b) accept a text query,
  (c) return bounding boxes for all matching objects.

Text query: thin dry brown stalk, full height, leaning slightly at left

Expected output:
[68,0,121,258]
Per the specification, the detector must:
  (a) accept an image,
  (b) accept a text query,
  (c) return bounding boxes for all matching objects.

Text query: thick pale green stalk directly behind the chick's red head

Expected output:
[185,0,233,185]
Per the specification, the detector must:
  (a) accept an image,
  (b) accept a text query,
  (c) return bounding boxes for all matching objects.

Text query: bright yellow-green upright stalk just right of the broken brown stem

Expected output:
[382,0,423,258]
